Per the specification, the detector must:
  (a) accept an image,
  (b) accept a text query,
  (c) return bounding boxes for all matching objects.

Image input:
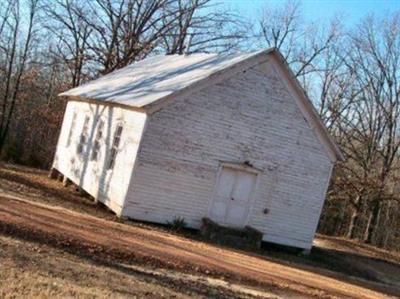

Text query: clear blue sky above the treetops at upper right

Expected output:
[217,0,400,25]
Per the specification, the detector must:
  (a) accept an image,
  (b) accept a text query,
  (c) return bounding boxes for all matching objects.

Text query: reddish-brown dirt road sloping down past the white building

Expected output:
[0,195,400,298]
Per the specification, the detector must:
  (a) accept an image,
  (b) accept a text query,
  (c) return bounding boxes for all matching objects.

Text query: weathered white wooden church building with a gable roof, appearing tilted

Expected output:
[53,49,342,249]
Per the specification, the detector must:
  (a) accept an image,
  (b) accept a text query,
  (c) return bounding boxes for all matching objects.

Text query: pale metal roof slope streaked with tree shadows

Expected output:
[60,50,265,108]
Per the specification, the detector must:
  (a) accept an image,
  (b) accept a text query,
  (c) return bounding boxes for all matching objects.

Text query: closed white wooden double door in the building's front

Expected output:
[210,167,256,227]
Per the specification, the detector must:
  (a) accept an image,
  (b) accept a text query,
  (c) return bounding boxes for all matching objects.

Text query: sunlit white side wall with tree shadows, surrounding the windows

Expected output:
[53,101,146,214]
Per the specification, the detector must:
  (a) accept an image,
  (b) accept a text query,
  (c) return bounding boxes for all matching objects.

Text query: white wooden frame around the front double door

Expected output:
[207,162,264,227]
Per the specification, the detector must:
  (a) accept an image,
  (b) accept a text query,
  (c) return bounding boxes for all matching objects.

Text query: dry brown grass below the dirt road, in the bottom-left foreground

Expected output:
[0,235,277,299]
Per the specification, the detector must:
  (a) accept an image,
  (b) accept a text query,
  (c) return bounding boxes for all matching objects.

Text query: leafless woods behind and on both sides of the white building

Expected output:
[0,0,400,250]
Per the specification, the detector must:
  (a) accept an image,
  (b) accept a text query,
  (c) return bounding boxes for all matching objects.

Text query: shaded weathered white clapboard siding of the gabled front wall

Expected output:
[122,60,332,248]
